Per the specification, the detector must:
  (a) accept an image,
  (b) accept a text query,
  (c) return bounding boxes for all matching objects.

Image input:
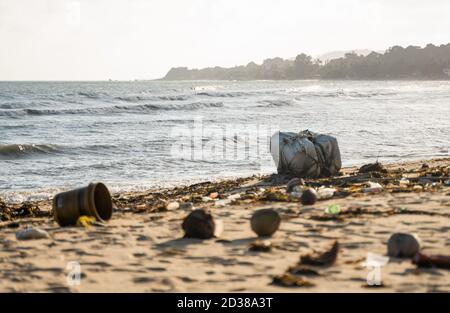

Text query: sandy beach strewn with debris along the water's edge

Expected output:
[0,158,450,292]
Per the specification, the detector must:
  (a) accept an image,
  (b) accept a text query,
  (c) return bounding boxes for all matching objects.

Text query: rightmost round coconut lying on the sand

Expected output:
[387,233,420,258]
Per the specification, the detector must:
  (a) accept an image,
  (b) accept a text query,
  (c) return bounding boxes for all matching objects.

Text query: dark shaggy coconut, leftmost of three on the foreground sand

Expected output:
[181,209,216,239]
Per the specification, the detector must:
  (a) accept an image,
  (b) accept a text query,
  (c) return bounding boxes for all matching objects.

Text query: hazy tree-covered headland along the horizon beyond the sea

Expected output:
[163,44,450,80]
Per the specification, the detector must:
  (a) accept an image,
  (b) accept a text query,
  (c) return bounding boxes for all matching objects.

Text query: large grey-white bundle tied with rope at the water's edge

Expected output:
[270,130,342,177]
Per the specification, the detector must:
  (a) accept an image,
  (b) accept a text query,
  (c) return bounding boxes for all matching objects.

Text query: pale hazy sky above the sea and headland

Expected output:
[0,0,450,80]
